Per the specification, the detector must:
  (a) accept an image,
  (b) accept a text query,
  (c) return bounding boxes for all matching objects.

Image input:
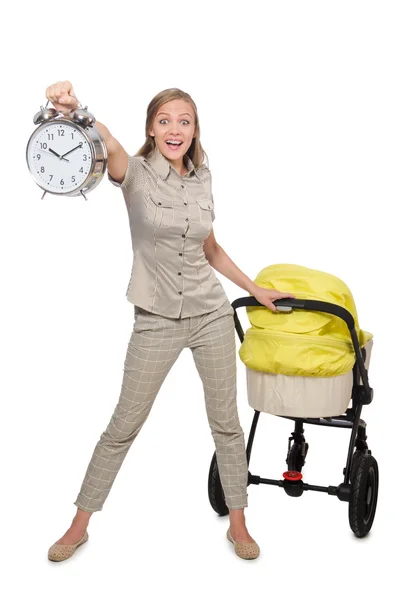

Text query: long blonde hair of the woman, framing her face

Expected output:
[135,88,208,169]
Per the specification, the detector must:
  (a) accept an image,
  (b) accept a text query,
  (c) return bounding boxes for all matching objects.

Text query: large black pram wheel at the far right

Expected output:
[349,453,379,537]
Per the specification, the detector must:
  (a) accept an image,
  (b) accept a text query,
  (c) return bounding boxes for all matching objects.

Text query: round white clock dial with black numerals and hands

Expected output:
[27,121,92,194]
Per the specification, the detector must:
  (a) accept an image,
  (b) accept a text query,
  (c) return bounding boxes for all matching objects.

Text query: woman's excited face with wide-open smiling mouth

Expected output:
[149,98,195,166]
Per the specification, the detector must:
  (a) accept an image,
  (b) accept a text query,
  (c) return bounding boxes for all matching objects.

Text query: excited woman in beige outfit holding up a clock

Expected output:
[46,81,293,561]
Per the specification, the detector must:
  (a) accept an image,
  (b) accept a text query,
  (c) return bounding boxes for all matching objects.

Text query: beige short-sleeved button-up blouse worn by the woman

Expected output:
[108,148,227,318]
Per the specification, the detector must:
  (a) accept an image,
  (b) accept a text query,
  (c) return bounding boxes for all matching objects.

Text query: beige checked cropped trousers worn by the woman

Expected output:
[74,300,248,512]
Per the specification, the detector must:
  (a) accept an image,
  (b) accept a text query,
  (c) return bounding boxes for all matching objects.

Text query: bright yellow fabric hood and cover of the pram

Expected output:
[239,264,373,377]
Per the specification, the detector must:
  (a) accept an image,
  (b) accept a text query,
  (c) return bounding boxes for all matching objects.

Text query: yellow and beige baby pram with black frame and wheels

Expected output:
[208,264,379,537]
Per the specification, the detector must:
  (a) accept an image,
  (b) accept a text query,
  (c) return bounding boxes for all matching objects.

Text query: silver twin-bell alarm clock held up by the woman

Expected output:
[26,102,108,200]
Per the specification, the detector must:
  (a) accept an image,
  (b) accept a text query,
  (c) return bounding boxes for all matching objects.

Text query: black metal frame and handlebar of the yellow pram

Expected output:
[231,296,373,502]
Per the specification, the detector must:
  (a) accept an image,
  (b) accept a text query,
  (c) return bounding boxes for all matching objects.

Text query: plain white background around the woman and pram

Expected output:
[0,0,397,600]
